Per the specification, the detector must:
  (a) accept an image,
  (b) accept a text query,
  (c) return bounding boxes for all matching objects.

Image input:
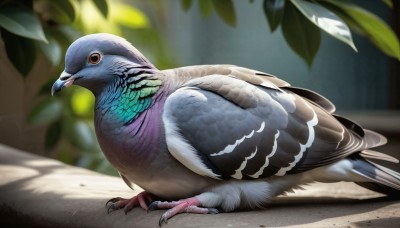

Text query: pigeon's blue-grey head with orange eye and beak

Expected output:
[51,33,157,95]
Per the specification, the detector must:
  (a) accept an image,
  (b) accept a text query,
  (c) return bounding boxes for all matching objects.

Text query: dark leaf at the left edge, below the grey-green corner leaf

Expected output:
[2,31,36,76]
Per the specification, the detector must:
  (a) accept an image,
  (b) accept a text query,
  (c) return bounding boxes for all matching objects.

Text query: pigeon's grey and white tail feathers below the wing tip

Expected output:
[351,154,400,197]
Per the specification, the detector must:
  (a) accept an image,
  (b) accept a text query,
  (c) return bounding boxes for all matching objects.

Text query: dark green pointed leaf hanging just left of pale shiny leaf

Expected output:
[282,4,321,66]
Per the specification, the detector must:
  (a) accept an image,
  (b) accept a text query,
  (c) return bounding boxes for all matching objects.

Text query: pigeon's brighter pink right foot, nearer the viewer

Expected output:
[148,198,219,226]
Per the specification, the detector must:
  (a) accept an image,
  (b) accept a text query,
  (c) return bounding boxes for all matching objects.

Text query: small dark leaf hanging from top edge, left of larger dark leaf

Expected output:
[263,0,285,32]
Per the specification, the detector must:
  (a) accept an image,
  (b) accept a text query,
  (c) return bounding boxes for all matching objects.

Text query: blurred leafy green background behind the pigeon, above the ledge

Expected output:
[0,0,400,174]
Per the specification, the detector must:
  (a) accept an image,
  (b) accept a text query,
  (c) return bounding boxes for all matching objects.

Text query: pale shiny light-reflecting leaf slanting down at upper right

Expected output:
[291,0,357,51]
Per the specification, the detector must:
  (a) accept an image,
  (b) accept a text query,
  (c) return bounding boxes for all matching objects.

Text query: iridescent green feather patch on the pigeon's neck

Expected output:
[99,79,162,125]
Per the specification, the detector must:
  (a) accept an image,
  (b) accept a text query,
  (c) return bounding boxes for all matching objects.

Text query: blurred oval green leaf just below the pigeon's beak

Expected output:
[28,97,63,124]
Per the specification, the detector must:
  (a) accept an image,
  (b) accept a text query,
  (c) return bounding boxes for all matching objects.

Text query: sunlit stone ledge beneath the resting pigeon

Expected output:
[0,145,400,228]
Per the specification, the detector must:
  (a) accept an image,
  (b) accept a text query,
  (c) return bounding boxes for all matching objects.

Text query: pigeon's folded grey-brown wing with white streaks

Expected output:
[163,65,390,179]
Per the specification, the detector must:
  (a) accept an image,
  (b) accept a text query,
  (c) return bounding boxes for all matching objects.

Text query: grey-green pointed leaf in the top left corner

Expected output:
[0,6,47,42]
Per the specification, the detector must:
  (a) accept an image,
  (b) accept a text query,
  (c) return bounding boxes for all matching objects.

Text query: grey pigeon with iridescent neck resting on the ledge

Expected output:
[51,33,400,226]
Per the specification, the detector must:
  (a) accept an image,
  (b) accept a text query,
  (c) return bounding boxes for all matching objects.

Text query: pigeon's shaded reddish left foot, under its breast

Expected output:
[106,192,153,214]
